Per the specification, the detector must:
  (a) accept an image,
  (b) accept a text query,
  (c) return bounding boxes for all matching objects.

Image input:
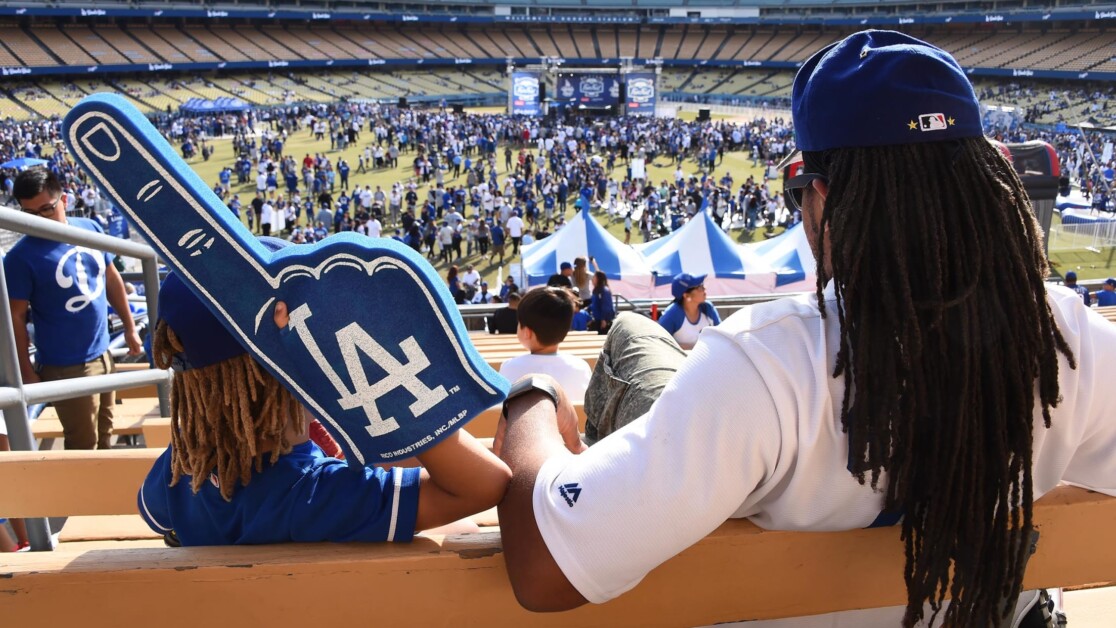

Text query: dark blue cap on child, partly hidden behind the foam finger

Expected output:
[158,238,288,369]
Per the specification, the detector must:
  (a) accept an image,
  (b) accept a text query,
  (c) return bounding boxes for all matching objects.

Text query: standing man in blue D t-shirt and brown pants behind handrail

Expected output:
[3,168,143,450]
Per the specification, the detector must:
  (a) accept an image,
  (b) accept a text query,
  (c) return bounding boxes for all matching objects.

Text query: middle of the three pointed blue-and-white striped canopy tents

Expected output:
[637,211,775,298]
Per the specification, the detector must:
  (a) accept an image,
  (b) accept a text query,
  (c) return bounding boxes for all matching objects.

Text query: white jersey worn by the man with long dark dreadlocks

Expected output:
[533,287,1116,626]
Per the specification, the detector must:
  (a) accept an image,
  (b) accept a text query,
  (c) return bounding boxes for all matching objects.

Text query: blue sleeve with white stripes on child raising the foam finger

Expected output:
[288,460,420,542]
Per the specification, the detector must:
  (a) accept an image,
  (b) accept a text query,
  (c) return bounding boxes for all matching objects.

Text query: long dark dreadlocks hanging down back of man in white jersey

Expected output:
[807,137,1077,627]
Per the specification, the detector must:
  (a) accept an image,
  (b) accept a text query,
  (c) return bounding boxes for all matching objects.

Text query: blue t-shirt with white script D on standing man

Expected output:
[3,218,114,366]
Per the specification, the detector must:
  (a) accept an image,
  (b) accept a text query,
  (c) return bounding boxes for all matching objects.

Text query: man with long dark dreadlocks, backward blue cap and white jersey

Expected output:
[497,31,1116,628]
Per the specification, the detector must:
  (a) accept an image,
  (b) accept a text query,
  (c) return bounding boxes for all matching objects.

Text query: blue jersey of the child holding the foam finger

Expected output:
[138,442,420,545]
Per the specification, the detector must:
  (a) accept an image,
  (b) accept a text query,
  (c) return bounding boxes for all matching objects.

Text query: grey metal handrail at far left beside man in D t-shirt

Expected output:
[0,207,171,551]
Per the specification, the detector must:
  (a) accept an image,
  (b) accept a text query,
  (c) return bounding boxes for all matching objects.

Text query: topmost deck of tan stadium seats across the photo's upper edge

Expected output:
[0,20,1116,80]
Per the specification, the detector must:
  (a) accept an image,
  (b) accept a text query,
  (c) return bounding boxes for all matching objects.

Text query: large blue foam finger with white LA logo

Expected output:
[62,95,508,464]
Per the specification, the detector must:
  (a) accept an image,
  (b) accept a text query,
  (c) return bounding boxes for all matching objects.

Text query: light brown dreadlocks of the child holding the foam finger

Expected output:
[152,320,304,501]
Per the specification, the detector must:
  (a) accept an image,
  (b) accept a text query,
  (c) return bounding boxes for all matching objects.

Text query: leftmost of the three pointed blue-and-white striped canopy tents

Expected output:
[522,212,653,299]
